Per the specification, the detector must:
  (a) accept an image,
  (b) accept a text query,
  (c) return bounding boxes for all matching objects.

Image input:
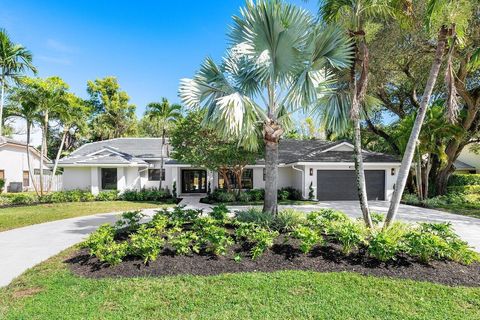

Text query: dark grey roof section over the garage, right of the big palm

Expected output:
[257,140,399,164]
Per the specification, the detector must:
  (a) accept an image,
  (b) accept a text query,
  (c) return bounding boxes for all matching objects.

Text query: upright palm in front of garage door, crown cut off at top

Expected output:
[320,0,392,228]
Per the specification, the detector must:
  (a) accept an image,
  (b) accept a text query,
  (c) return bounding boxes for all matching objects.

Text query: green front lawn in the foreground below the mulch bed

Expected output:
[0,249,480,320]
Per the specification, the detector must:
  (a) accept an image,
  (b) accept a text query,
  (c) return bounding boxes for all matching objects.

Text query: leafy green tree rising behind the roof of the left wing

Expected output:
[87,77,137,141]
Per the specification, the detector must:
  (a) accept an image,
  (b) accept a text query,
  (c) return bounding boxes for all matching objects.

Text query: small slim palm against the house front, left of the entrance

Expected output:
[145,98,182,189]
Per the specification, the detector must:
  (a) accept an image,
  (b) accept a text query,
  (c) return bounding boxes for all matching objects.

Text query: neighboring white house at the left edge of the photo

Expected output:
[0,137,49,192]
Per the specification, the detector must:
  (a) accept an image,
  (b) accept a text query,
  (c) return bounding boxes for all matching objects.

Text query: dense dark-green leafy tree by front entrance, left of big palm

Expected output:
[170,110,260,191]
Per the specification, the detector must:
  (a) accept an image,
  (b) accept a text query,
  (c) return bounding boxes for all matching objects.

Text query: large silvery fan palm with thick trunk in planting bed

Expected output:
[179,0,352,214]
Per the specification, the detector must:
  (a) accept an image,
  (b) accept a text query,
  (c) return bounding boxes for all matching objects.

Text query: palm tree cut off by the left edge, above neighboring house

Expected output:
[0,29,36,136]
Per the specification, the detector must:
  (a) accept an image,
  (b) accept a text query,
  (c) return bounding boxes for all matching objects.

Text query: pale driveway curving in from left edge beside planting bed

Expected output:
[0,209,159,287]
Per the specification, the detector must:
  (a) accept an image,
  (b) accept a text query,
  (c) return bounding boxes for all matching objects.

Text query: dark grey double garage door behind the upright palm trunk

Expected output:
[317,170,385,200]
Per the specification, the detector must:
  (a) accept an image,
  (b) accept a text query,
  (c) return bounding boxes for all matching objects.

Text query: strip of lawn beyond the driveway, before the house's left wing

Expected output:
[0,201,171,231]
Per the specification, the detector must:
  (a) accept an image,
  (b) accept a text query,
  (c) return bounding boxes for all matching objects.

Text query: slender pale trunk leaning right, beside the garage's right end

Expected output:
[384,27,448,228]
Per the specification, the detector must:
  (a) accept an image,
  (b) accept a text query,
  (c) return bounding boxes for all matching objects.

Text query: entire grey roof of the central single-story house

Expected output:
[59,138,399,166]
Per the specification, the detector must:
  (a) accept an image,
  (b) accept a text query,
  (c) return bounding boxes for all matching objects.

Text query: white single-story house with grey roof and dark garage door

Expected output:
[59,138,400,200]
